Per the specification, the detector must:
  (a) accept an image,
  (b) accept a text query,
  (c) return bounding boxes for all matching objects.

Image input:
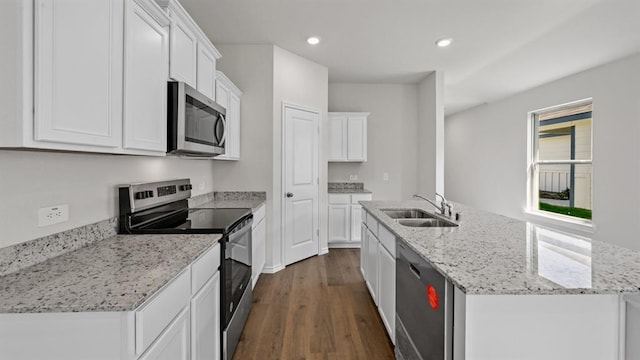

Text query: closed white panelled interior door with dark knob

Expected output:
[283,105,320,265]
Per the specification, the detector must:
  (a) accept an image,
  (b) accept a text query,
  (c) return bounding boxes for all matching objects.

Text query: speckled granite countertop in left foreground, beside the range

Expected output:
[0,234,220,313]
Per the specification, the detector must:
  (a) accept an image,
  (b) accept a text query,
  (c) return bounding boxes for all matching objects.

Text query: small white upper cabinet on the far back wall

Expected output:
[328,112,369,162]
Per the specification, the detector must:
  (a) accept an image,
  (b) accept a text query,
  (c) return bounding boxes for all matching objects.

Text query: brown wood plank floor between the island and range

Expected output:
[233,249,395,360]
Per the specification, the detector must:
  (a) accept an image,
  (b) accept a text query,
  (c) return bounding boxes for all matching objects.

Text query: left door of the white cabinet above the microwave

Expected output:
[169,14,198,88]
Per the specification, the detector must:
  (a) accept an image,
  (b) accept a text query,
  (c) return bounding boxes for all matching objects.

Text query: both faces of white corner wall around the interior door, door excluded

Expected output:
[214,45,328,272]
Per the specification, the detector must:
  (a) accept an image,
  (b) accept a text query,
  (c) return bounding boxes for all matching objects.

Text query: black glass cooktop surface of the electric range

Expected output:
[129,208,251,234]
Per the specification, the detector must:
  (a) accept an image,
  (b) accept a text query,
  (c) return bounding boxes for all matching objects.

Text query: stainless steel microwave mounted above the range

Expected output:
[167,81,226,157]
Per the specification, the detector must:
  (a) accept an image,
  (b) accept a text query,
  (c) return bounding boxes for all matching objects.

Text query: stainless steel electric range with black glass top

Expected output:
[118,179,253,360]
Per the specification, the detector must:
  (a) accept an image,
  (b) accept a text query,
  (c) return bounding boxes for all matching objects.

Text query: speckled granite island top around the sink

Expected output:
[361,201,640,295]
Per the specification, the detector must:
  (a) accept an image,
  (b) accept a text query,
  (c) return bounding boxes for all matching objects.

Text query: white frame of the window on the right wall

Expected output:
[525,98,594,231]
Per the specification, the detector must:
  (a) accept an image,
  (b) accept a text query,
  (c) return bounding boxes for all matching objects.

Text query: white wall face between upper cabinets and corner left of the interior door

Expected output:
[214,45,280,271]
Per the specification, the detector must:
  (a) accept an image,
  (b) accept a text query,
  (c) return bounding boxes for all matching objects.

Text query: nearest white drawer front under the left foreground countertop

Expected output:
[136,269,191,354]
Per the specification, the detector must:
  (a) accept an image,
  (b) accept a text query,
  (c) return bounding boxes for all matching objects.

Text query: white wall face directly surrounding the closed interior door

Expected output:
[267,46,329,265]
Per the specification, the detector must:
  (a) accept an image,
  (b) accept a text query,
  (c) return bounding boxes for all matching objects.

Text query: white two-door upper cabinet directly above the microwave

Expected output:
[156,0,221,100]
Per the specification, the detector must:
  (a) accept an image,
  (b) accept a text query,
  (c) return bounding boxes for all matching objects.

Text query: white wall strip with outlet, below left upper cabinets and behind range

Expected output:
[0,149,214,247]
